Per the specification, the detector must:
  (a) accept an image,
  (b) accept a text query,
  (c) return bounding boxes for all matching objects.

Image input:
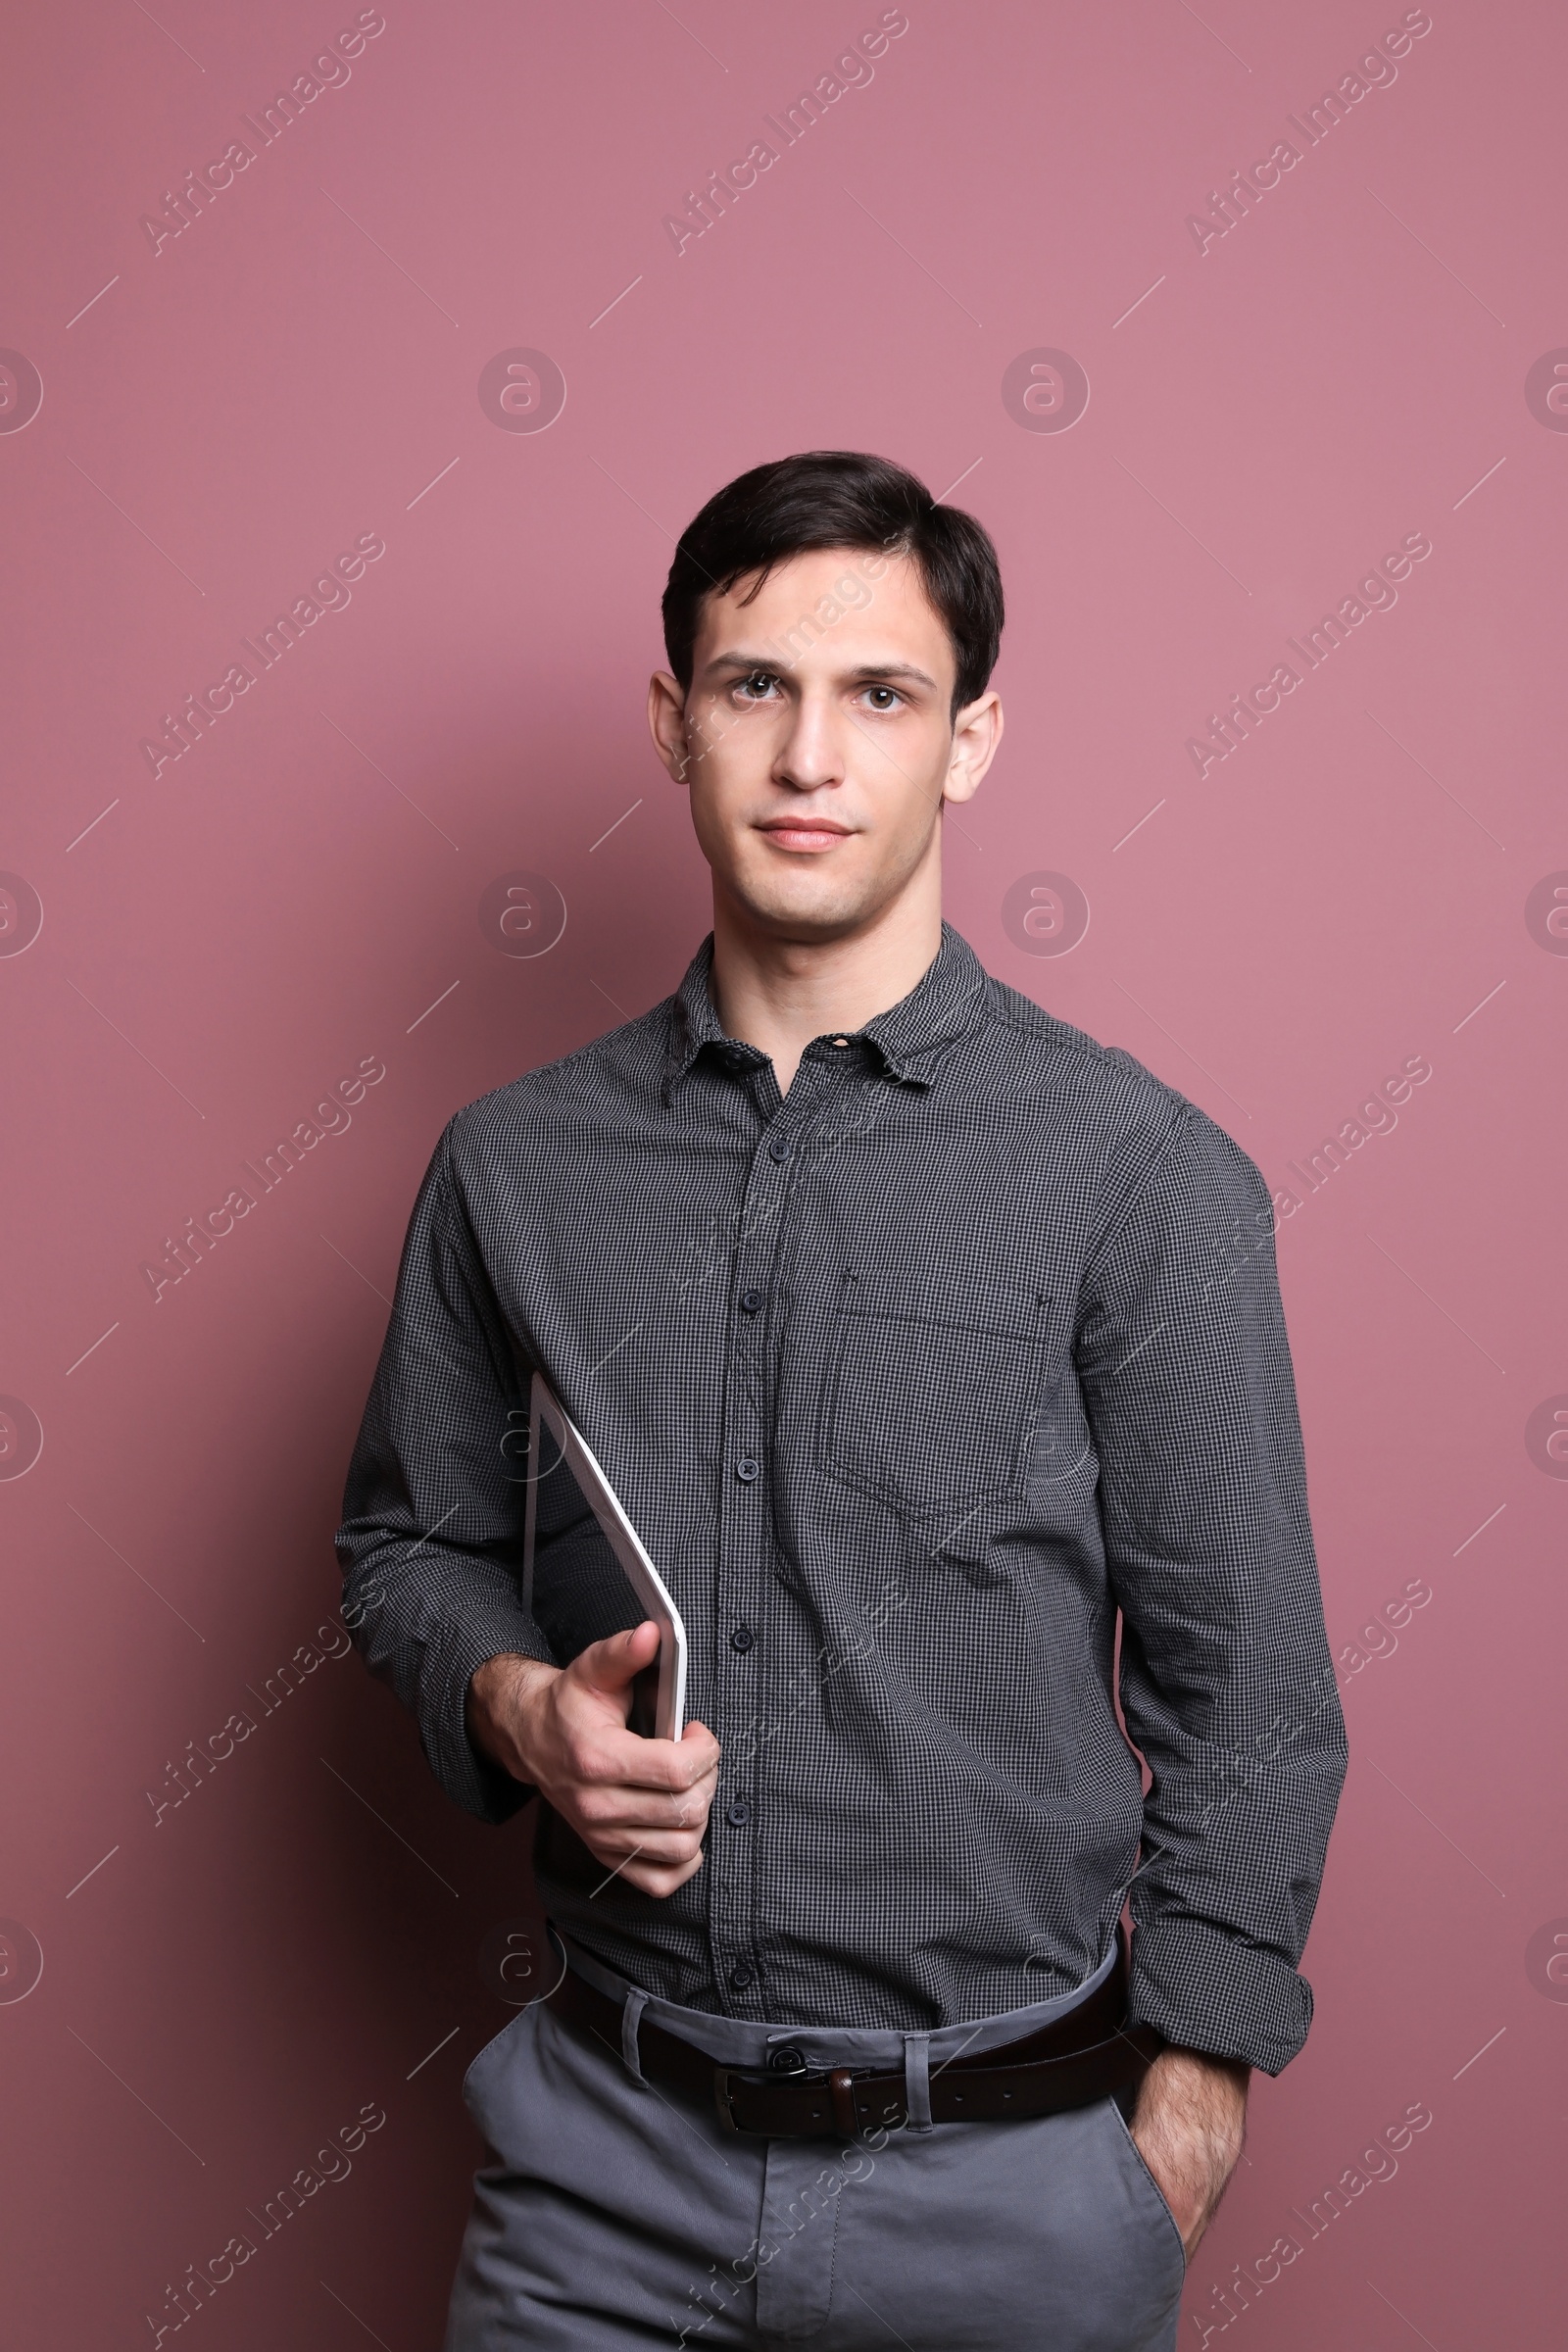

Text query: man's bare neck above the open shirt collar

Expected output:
[710,870,943,1094]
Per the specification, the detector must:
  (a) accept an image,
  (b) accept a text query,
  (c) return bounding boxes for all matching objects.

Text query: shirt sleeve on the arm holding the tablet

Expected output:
[336,1127,550,1823]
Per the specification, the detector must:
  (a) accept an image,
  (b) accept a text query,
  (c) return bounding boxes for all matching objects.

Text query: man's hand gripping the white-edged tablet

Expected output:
[467,1618,719,1895]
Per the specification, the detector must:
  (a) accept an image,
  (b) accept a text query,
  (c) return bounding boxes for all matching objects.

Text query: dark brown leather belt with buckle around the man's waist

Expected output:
[550,1938,1163,2140]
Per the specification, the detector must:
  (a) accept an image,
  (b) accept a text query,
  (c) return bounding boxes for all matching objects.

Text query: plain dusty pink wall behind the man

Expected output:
[0,0,1568,2352]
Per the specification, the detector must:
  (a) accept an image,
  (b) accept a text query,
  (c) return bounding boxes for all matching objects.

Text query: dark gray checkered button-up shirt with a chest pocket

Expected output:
[338,929,1345,2075]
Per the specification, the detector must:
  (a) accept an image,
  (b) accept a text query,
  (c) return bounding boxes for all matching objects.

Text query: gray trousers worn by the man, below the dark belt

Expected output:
[444,1954,1185,2352]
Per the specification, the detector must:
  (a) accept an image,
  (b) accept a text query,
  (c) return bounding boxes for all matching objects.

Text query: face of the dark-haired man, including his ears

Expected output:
[649,548,1002,941]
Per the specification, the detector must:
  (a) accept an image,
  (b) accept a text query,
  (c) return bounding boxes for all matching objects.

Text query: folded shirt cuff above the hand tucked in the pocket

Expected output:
[1128,1903,1312,2075]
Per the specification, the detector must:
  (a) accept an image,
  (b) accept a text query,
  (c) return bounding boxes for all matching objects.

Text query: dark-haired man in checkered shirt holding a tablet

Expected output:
[338,452,1345,2352]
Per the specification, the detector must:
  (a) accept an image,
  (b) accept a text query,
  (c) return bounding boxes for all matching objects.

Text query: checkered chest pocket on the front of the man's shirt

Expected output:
[818,1275,1060,1512]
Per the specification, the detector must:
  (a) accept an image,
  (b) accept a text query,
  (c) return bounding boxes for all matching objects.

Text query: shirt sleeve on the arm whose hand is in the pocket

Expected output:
[1074,1103,1348,2075]
